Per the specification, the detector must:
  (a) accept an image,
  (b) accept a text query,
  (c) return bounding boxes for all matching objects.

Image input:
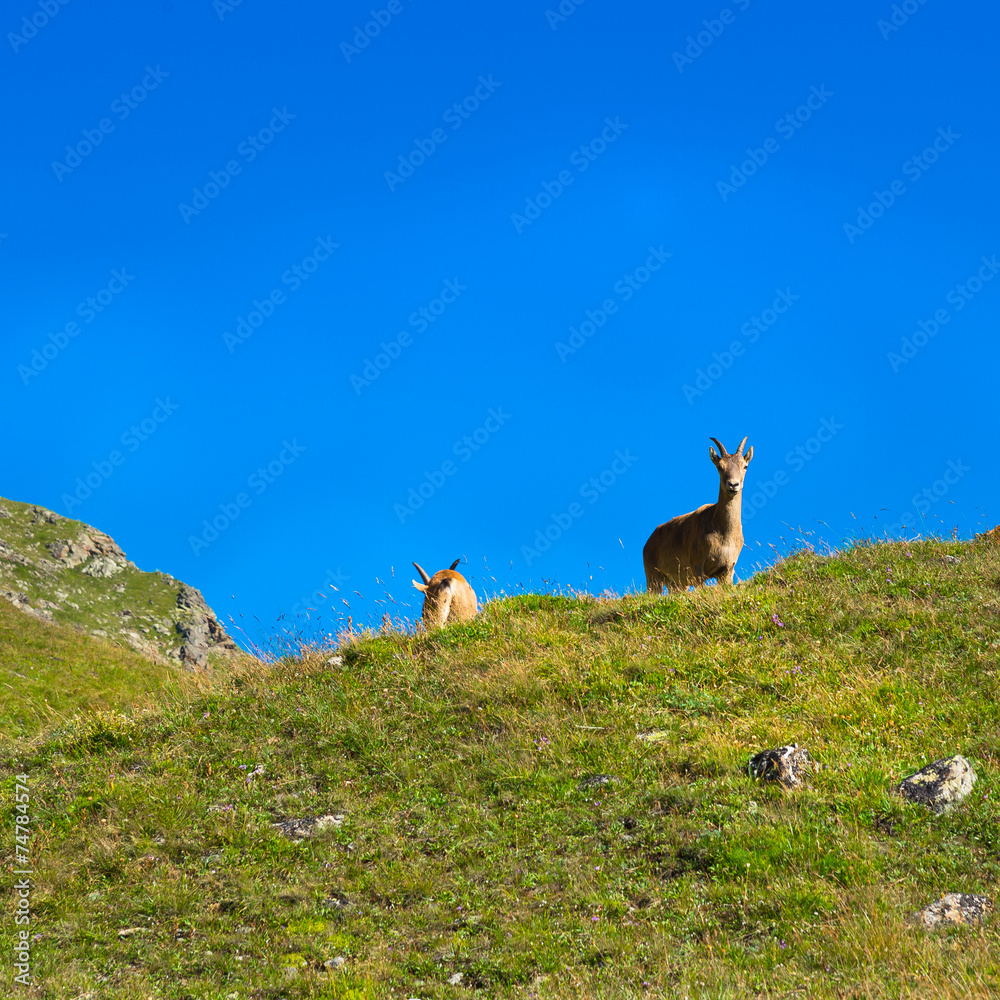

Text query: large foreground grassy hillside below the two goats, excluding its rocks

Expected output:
[0,542,1000,1000]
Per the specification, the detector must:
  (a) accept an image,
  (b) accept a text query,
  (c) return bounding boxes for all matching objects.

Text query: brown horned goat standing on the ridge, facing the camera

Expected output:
[642,438,753,594]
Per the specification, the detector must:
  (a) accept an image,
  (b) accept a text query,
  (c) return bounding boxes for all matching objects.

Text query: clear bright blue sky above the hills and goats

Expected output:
[0,0,1000,652]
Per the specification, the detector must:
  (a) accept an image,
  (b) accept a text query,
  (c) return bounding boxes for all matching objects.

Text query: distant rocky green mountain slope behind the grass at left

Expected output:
[0,500,239,669]
